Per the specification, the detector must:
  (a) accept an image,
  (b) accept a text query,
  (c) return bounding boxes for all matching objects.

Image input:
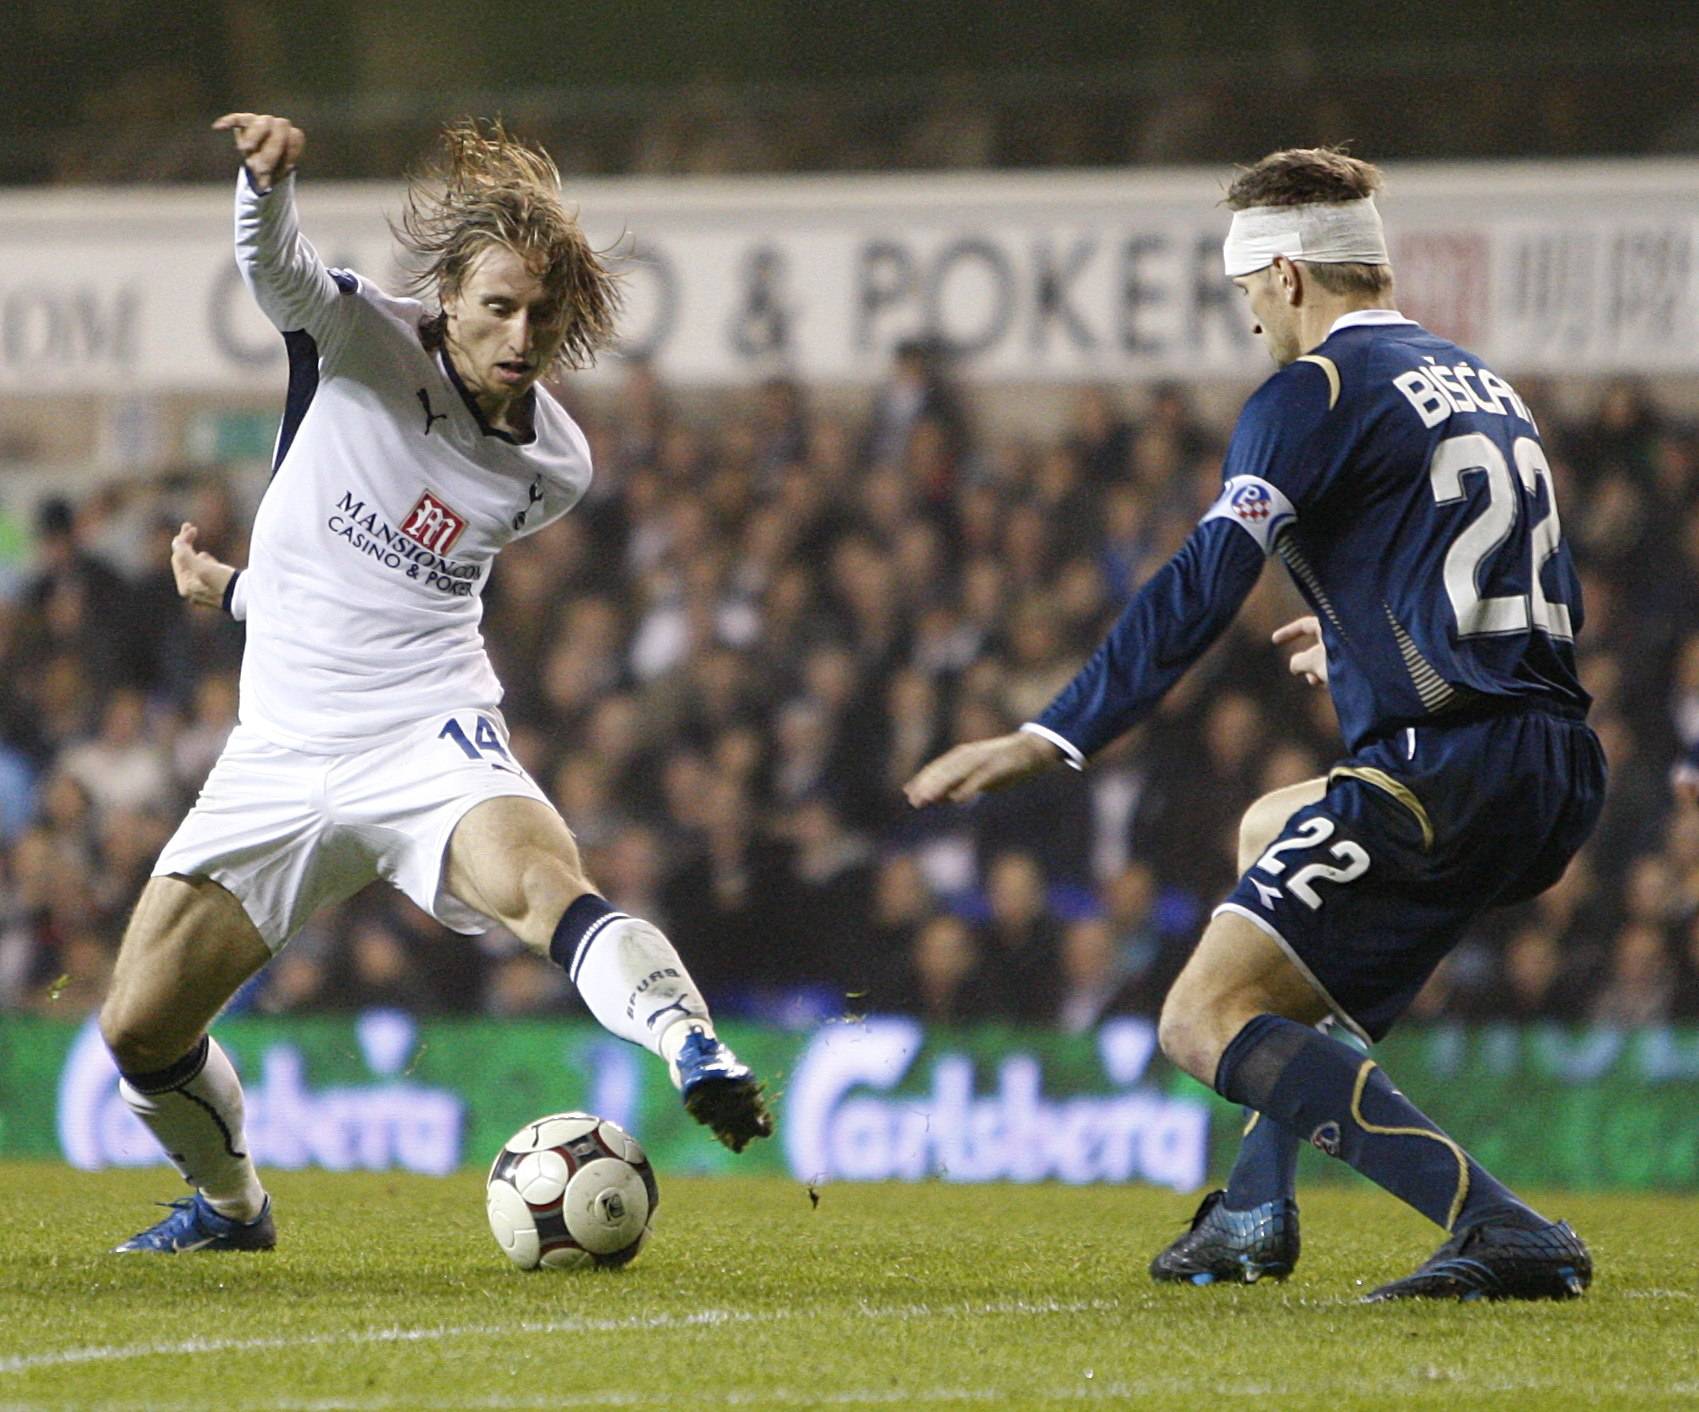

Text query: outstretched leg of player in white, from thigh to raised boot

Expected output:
[443,795,773,1152]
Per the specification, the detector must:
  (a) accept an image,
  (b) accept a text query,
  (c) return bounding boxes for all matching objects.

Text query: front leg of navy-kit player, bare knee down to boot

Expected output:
[1159,912,1592,1298]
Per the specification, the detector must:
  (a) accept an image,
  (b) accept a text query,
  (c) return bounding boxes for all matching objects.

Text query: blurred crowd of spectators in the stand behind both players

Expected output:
[0,358,1699,1030]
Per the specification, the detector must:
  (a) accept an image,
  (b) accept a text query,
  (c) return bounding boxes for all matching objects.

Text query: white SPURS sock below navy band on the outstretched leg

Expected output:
[573,912,714,1062]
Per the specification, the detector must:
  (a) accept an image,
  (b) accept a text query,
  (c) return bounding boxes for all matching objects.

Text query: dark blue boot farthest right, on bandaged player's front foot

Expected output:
[1363,1213,1592,1303]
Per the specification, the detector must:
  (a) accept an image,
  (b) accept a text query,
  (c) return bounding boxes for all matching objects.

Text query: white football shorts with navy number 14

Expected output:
[153,710,554,953]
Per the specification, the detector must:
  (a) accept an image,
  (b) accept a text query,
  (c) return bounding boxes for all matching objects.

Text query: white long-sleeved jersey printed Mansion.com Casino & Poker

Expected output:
[231,177,590,754]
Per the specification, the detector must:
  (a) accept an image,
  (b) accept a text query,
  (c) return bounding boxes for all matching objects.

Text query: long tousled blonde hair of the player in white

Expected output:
[391,117,622,372]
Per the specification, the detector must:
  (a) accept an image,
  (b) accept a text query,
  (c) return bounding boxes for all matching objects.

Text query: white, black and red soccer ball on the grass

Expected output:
[484,1113,661,1269]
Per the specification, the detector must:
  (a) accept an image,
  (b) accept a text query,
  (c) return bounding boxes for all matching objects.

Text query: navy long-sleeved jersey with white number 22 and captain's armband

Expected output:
[1033,309,1589,761]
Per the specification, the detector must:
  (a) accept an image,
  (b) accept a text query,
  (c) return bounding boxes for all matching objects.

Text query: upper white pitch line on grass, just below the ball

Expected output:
[0,1300,1120,1375]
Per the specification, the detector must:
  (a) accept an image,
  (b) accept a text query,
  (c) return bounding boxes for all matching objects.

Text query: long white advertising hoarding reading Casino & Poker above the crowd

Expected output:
[0,161,1699,394]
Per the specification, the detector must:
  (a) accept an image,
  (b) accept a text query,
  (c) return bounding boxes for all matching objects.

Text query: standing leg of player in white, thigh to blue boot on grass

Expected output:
[100,877,275,1252]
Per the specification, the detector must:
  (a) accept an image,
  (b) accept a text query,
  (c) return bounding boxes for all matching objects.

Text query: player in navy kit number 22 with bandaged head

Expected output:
[907,150,1606,1300]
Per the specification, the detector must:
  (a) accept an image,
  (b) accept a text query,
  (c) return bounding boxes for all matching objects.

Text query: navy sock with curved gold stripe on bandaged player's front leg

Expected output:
[1215,1014,1538,1230]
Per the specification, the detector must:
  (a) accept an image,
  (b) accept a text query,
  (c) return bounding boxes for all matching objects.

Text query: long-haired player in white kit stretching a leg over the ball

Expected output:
[100,112,771,1252]
